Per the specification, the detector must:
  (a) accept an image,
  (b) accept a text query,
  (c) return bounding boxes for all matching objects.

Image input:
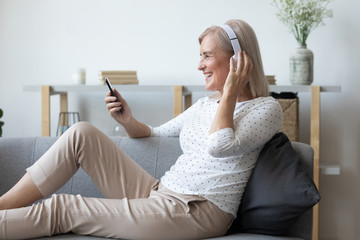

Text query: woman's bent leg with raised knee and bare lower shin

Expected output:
[0,122,157,209]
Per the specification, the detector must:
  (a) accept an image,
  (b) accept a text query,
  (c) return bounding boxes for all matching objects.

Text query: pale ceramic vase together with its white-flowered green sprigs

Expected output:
[272,0,333,85]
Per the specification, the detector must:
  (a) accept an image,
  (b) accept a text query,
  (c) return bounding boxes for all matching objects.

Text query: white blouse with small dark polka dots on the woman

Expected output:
[151,97,283,217]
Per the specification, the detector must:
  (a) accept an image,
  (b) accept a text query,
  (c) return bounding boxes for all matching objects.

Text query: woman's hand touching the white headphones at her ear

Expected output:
[223,51,253,99]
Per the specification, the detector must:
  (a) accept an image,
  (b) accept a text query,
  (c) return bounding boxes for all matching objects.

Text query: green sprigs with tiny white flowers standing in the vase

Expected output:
[272,0,333,45]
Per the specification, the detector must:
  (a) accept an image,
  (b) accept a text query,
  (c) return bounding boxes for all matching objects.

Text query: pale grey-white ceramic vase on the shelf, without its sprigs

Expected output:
[290,44,314,85]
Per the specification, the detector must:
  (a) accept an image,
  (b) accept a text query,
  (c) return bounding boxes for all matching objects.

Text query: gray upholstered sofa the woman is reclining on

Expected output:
[0,137,313,240]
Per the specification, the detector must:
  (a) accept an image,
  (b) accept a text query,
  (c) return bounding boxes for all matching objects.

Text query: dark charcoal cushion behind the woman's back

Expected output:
[229,133,320,236]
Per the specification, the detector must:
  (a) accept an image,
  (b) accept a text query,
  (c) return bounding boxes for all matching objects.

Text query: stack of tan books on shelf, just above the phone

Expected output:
[99,71,139,84]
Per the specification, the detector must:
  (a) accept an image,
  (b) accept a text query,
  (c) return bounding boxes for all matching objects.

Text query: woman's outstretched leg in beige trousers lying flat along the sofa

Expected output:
[0,185,233,240]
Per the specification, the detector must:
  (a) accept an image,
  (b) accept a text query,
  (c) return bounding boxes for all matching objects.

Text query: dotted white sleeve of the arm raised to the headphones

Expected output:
[208,100,283,157]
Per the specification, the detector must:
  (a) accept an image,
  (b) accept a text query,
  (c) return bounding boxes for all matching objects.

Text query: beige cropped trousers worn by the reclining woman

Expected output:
[0,122,233,239]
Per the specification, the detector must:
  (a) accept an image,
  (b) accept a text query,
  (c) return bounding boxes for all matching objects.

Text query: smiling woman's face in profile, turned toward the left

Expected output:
[198,34,230,93]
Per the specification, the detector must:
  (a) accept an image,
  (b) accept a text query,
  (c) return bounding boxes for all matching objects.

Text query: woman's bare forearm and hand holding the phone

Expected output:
[104,89,151,138]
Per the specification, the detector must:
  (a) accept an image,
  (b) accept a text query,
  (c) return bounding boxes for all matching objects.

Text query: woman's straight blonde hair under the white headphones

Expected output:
[199,19,269,97]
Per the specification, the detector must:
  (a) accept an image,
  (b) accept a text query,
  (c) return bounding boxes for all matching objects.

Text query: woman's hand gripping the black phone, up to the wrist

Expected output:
[104,88,132,126]
